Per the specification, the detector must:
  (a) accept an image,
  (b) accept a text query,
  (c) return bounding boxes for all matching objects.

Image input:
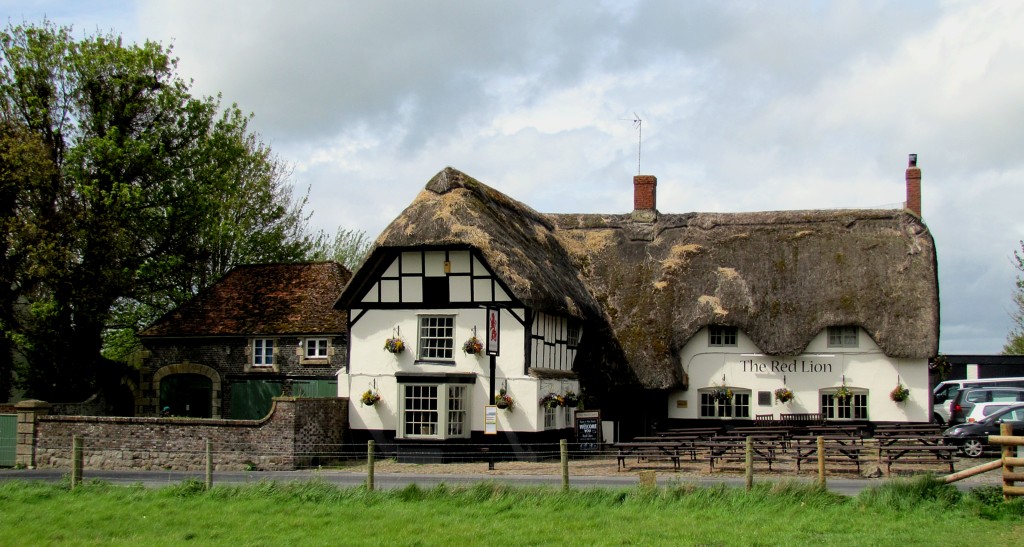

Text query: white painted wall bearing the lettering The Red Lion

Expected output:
[669,329,931,422]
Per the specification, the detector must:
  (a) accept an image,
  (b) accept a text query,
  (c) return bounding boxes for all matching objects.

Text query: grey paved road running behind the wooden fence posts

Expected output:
[0,469,1000,496]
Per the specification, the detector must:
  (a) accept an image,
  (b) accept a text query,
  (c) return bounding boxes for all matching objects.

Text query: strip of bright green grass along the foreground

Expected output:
[0,477,1024,547]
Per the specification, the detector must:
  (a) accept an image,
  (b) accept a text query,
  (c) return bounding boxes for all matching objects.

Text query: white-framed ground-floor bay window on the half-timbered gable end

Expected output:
[398,383,470,439]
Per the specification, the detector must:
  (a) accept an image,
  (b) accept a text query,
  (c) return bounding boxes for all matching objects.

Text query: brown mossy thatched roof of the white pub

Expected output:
[342,168,939,389]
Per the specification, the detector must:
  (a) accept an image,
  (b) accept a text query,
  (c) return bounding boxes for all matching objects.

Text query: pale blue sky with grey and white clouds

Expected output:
[0,0,1024,353]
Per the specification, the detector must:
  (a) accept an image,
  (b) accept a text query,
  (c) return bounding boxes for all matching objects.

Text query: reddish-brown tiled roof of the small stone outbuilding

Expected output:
[139,262,351,337]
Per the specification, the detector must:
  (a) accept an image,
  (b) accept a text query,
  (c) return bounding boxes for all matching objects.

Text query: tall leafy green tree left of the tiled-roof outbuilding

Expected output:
[0,22,311,401]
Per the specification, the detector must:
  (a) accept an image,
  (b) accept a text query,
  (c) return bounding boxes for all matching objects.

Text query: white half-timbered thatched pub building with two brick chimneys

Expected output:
[337,157,939,441]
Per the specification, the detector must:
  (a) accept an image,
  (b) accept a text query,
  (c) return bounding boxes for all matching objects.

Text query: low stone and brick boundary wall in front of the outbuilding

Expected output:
[17,397,348,470]
